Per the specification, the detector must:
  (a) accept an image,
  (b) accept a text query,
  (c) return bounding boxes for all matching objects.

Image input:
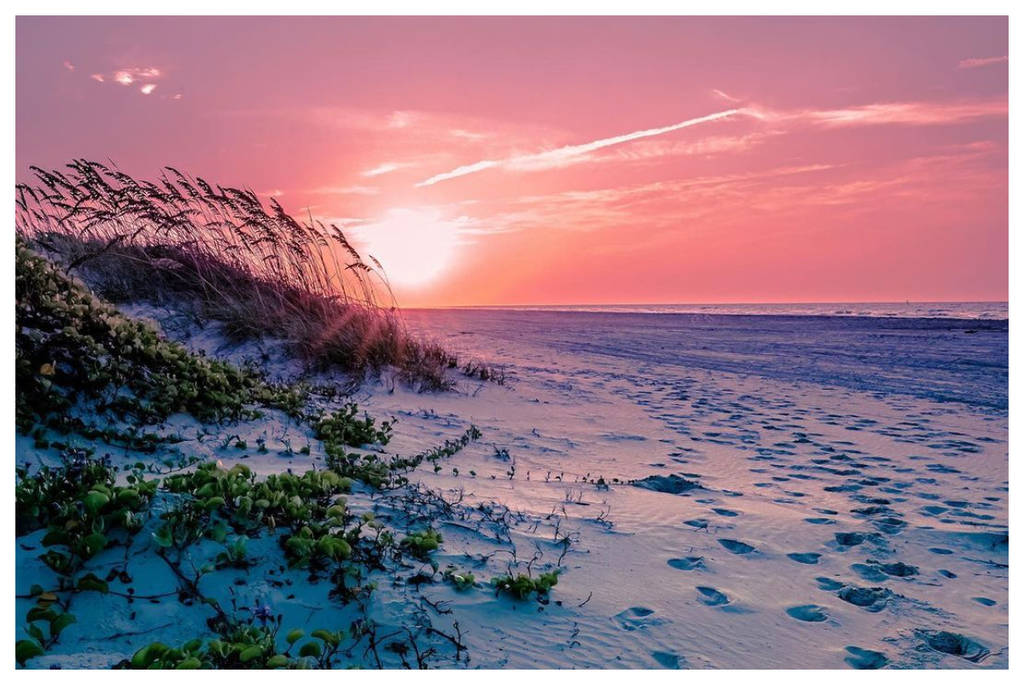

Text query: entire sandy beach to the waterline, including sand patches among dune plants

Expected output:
[18,309,1009,669]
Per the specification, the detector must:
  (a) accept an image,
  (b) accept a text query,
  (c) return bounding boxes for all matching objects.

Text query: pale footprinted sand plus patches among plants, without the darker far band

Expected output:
[17,305,1009,669]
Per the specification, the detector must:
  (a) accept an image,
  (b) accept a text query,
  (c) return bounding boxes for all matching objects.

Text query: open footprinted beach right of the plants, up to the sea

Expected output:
[374,310,1008,668]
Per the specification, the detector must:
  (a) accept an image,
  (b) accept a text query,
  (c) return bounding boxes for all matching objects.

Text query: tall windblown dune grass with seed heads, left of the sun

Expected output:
[15,160,479,390]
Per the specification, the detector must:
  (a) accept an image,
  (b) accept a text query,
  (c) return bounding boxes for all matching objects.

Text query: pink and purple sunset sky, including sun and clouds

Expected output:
[15,17,1009,306]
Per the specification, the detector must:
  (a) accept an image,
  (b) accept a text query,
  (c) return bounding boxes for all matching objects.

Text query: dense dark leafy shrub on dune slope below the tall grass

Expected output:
[15,240,274,430]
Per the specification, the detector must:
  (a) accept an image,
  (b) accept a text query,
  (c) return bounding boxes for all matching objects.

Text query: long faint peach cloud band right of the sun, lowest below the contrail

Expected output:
[474,140,1006,250]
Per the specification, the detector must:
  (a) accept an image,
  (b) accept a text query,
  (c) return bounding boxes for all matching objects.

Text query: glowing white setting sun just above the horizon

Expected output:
[354,209,463,288]
